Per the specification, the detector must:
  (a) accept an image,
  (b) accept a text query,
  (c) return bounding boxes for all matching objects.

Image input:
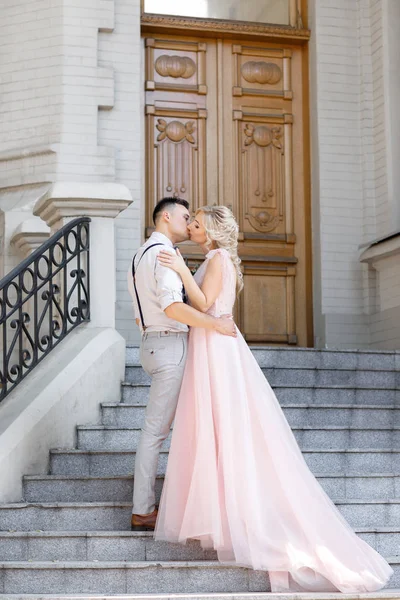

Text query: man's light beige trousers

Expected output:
[132,331,188,515]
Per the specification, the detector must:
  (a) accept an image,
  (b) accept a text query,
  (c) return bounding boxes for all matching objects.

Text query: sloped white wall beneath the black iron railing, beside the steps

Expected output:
[0,326,125,502]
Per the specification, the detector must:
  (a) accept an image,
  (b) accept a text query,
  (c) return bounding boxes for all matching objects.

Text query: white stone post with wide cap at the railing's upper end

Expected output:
[33,182,132,328]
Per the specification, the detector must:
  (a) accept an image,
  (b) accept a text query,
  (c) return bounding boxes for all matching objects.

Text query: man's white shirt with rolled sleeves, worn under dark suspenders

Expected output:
[128,231,189,333]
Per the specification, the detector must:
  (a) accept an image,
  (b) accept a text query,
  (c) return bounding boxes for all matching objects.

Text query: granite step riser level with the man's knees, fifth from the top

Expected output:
[77,423,400,450]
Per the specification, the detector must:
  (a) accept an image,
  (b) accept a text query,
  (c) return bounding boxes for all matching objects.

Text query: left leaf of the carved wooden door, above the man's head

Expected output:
[145,38,211,234]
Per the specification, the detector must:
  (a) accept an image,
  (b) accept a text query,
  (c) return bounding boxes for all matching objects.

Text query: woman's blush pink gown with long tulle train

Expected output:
[155,249,392,593]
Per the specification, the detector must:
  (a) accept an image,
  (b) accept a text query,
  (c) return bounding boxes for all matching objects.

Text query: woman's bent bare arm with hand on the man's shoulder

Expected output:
[158,250,222,312]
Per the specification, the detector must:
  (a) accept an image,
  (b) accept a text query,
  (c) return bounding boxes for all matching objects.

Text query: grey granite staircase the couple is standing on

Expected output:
[0,347,400,600]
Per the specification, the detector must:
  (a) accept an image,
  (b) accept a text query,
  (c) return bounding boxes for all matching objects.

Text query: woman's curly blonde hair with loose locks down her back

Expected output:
[196,206,243,293]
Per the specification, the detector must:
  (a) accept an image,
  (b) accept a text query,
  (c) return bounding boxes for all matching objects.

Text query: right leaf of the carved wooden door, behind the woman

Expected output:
[224,42,308,345]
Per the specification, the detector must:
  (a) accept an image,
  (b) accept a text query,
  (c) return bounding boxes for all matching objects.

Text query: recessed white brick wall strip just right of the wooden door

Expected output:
[311,0,365,346]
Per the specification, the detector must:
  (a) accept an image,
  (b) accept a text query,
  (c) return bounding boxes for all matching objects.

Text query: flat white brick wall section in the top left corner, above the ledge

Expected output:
[0,0,62,151]
